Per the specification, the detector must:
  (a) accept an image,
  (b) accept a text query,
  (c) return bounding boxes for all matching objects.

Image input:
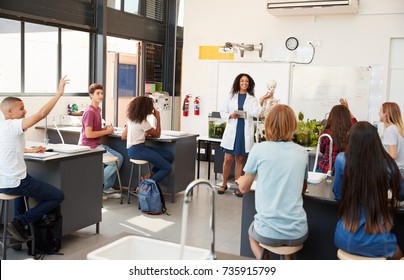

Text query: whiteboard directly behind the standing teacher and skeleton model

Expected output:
[216,61,291,111]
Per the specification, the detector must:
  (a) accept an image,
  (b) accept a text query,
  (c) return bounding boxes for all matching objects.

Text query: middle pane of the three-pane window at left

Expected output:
[25,23,58,93]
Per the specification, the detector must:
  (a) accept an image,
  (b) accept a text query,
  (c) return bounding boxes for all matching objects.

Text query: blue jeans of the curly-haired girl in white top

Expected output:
[128,144,174,183]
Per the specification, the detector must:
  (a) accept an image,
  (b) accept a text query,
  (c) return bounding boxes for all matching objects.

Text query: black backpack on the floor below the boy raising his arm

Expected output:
[27,206,63,259]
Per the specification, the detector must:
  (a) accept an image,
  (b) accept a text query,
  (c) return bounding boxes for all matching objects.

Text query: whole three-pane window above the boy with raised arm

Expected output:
[0,18,91,95]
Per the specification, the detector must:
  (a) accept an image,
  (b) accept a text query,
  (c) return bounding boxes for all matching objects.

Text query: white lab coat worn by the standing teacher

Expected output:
[220,93,262,153]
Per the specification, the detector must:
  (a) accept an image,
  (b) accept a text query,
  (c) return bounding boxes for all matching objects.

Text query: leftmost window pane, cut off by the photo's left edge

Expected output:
[0,18,21,93]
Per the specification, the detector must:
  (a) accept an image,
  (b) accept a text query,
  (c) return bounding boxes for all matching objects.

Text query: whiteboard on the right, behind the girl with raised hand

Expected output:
[290,65,371,120]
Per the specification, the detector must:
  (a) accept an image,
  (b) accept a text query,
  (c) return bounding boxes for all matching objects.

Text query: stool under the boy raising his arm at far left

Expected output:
[0,193,35,260]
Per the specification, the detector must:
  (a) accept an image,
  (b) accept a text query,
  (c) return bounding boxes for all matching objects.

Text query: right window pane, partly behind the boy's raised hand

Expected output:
[61,29,90,92]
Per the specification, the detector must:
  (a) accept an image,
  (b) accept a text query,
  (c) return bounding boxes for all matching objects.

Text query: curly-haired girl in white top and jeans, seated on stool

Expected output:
[122,96,174,183]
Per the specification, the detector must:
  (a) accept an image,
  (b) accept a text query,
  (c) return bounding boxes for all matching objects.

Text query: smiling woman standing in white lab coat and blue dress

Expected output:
[218,73,262,197]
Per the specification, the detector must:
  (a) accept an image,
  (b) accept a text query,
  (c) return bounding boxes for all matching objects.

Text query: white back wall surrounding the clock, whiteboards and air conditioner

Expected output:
[181,0,404,135]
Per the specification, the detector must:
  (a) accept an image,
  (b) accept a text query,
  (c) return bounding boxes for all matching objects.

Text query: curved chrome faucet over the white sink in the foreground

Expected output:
[180,179,216,260]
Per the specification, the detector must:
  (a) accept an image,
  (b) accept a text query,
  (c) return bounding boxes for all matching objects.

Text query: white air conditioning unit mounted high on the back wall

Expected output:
[267,0,359,16]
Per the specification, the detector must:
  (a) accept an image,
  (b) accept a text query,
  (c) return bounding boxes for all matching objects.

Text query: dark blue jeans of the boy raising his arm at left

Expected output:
[0,173,65,226]
